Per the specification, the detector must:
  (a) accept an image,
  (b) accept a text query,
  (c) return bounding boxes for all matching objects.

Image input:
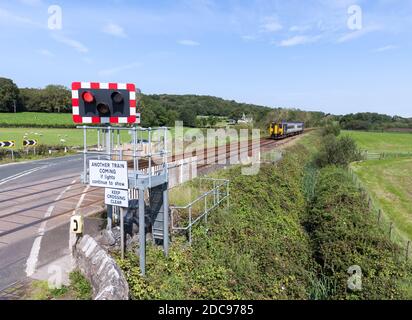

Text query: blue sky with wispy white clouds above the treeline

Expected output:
[0,0,412,117]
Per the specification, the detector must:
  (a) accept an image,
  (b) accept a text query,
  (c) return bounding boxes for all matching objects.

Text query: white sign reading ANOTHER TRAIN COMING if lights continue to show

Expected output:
[89,160,129,190]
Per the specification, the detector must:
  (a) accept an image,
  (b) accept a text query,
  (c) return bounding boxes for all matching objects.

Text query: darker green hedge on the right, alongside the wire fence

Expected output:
[307,167,411,299]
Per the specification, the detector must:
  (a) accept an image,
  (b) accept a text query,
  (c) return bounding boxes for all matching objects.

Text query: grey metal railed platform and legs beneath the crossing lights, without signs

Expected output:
[77,126,170,275]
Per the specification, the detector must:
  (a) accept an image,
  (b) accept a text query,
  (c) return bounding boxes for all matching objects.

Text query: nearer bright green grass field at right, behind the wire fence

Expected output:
[352,158,412,240]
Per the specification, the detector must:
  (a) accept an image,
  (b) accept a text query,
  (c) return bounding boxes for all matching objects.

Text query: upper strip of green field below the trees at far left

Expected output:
[0,112,75,127]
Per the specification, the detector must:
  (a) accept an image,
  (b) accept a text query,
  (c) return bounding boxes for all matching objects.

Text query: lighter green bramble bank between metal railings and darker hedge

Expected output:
[119,148,314,299]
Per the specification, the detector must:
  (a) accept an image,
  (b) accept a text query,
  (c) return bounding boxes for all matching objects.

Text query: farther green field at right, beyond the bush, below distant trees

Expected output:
[342,131,412,153]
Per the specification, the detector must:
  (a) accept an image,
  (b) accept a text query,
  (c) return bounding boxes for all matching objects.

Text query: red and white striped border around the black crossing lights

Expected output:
[72,82,140,124]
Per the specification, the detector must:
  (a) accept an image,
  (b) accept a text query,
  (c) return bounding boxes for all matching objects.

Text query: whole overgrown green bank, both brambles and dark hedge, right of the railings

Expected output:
[114,140,411,300]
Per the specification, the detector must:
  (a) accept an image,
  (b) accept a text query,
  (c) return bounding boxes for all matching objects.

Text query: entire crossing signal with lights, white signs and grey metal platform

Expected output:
[72,82,170,275]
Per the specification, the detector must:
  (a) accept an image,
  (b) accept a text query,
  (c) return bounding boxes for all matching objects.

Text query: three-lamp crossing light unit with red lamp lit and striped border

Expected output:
[72,82,140,124]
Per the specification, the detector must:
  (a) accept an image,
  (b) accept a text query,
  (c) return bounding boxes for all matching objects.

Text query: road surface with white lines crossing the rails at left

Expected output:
[0,155,103,291]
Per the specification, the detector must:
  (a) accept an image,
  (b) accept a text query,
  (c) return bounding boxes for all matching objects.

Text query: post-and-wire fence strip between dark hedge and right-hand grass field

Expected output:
[348,167,412,262]
